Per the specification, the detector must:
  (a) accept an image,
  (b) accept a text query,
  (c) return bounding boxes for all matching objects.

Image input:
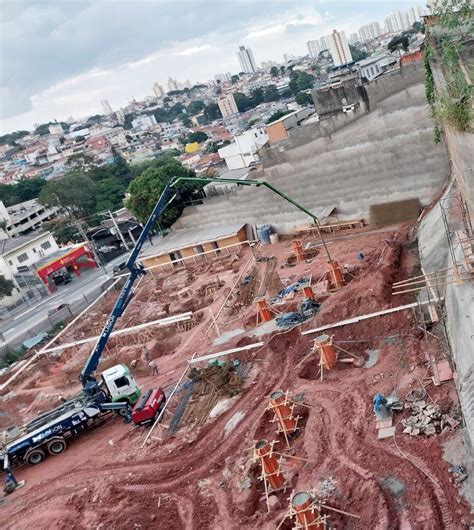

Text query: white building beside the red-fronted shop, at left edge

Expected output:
[0,232,59,307]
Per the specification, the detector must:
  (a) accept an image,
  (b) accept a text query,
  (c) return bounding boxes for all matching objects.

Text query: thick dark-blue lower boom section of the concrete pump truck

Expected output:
[80,185,176,393]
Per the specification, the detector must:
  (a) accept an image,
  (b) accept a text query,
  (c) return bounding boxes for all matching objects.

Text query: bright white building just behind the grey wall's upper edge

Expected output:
[218,128,268,170]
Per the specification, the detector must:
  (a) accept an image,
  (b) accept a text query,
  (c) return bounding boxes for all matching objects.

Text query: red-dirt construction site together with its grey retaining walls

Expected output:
[0,38,474,530]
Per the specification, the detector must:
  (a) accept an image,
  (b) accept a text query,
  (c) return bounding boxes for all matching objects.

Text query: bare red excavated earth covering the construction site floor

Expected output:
[0,225,470,530]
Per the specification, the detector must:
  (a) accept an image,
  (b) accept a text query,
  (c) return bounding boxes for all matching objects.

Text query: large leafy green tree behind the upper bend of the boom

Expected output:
[126,155,202,228]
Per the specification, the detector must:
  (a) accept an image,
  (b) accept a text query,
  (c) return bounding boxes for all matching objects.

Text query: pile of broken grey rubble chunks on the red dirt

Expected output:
[401,400,460,436]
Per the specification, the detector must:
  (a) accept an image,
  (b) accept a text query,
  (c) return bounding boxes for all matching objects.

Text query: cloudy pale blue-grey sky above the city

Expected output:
[0,0,416,134]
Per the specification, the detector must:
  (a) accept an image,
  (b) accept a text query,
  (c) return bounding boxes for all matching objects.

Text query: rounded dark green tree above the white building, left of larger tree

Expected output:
[39,171,96,219]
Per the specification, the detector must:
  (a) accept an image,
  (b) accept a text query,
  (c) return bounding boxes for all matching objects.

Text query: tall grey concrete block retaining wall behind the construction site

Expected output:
[177,84,450,233]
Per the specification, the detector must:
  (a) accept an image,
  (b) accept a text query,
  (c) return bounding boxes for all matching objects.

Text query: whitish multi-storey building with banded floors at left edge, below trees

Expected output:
[0,199,57,240]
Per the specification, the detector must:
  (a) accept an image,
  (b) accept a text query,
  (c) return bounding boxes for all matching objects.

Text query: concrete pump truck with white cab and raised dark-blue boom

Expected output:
[0,186,176,470]
